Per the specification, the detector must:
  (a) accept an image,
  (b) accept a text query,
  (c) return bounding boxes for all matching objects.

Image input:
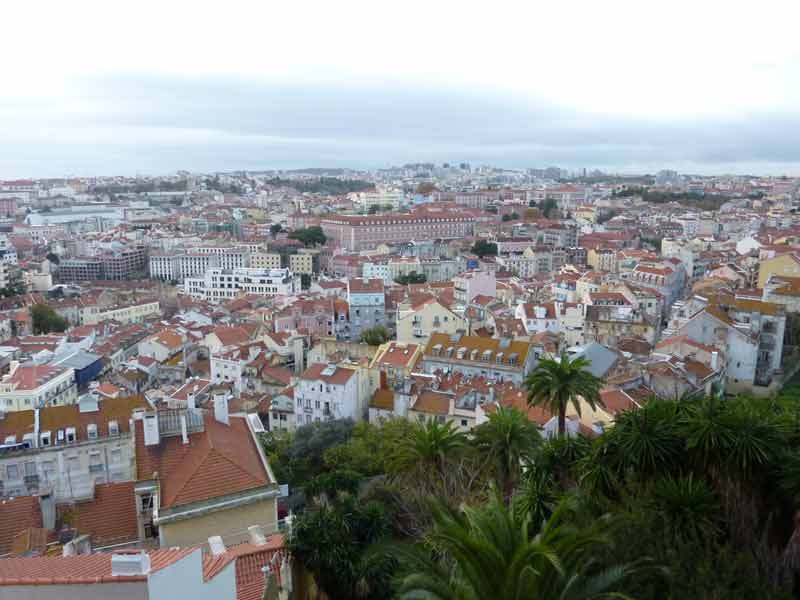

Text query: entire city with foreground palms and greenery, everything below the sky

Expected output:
[0,162,800,600]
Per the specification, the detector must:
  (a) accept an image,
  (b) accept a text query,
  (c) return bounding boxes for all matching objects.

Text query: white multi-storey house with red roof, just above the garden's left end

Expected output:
[294,363,366,426]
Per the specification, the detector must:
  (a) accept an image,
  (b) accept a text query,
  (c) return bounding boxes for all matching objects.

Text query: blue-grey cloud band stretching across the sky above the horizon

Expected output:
[0,75,800,176]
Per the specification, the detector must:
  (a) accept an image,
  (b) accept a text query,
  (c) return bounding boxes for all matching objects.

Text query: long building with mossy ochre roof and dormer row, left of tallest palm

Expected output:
[422,333,536,385]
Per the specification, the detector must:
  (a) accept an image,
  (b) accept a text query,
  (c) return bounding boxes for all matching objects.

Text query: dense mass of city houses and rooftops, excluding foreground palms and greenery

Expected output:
[0,165,800,598]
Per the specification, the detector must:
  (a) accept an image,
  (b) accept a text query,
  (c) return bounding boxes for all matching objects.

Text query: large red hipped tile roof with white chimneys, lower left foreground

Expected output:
[136,416,274,508]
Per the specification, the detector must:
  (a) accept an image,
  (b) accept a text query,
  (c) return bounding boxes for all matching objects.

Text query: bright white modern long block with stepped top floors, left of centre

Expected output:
[184,268,300,302]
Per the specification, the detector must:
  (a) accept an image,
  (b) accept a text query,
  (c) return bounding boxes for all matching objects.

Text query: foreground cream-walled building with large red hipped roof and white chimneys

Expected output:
[134,408,280,548]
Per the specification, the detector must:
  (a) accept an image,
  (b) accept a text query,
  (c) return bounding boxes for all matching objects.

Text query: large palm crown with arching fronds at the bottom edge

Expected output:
[398,492,640,600]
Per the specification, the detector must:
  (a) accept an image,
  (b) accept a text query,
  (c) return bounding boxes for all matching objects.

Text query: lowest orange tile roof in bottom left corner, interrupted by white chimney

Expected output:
[0,548,199,586]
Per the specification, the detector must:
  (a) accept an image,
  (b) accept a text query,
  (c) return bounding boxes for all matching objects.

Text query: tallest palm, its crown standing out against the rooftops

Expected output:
[525,352,605,437]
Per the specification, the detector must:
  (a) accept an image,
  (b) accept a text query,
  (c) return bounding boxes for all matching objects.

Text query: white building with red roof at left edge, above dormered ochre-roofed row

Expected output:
[0,361,78,412]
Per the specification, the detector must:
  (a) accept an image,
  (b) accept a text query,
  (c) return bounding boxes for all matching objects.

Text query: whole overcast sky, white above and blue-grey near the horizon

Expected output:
[0,0,800,178]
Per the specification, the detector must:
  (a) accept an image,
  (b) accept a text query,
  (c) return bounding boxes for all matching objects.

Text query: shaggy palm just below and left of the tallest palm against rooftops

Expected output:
[475,406,542,501]
